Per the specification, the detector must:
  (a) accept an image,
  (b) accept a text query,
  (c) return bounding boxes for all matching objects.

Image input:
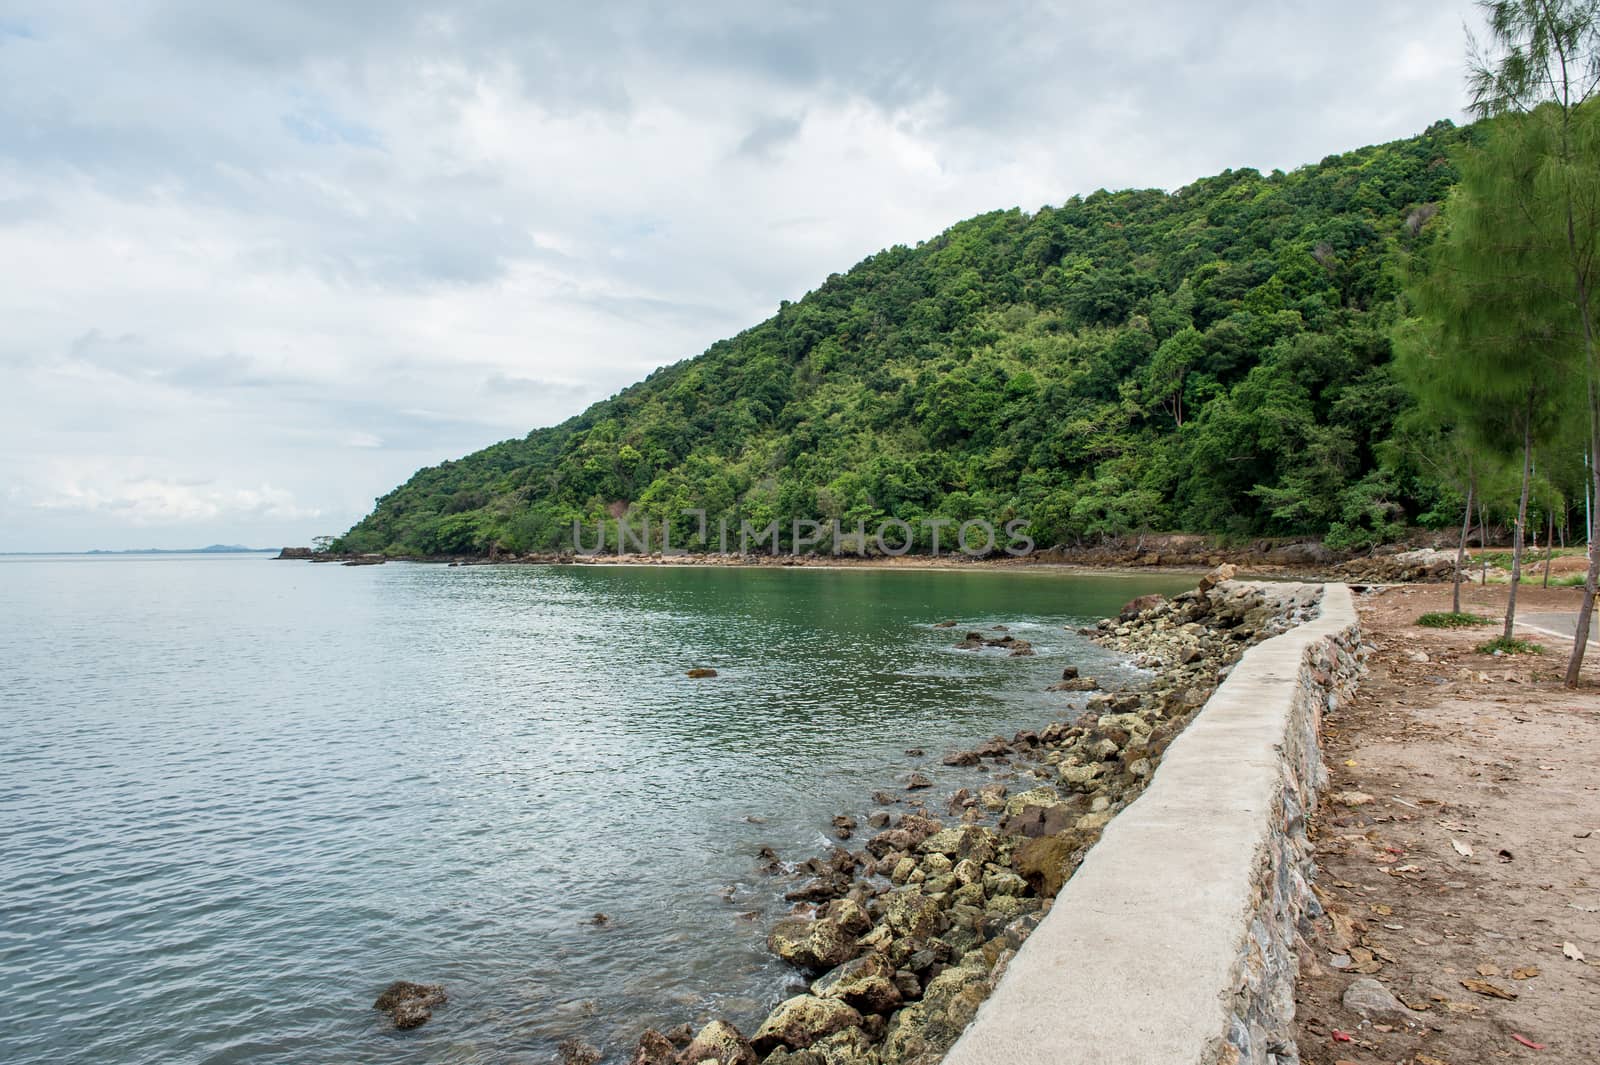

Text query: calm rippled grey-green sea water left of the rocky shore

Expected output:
[0,556,1189,1065]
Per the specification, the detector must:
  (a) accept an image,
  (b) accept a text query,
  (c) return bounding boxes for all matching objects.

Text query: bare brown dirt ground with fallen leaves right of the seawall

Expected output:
[1296,585,1600,1065]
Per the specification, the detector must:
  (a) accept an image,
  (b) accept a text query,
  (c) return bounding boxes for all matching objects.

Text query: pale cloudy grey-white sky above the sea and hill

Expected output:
[0,0,1474,552]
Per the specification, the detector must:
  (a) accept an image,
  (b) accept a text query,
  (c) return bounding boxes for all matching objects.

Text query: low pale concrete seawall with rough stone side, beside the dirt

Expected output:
[944,584,1360,1065]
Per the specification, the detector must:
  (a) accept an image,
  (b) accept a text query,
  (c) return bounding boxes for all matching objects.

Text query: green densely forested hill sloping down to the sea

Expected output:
[338,122,1474,555]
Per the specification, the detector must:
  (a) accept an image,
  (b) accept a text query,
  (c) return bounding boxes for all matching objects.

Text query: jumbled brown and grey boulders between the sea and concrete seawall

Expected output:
[632,568,1317,1065]
